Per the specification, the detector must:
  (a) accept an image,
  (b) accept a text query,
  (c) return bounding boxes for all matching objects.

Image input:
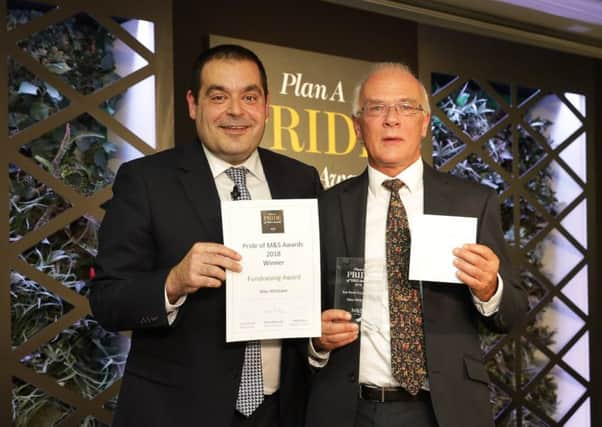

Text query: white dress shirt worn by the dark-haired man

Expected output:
[165,145,282,394]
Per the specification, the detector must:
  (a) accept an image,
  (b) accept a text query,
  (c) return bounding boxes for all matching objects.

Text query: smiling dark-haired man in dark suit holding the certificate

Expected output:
[90,45,321,427]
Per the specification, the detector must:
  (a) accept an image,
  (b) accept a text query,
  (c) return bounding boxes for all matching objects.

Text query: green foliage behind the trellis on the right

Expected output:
[431,82,558,426]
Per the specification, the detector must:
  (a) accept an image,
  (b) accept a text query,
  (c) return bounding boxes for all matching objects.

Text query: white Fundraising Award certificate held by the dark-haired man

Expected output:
[222,199,321,342]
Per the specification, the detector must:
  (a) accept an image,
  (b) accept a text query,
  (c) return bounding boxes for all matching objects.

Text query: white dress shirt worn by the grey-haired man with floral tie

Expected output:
[309,159,503,388]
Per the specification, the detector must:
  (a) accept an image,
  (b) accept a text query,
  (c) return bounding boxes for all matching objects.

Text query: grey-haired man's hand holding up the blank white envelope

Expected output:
[454,244,500,301]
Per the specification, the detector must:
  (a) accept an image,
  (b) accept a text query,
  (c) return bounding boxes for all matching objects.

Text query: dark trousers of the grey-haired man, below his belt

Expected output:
[354,399,437,427]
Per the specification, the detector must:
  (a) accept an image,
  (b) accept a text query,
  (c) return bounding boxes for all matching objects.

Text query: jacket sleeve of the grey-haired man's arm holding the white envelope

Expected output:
[479,191,528,332]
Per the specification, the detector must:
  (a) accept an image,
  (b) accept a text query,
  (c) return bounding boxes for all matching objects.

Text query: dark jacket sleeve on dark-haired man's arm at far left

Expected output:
[90,163,169,331]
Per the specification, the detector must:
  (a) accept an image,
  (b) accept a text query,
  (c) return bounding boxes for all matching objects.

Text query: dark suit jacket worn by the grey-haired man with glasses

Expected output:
[306,165,527,427]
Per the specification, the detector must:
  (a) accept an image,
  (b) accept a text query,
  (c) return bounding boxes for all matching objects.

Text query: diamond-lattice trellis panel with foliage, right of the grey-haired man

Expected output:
[428,73,590,426]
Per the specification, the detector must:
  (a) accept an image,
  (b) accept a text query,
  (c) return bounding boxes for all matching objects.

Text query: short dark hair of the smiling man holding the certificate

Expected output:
[190,44,268,101]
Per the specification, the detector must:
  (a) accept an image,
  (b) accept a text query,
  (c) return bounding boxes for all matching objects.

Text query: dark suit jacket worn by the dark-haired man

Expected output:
[90,141,322,427]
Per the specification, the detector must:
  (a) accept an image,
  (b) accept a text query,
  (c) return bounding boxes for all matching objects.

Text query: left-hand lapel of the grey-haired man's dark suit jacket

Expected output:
[339,169,368,258]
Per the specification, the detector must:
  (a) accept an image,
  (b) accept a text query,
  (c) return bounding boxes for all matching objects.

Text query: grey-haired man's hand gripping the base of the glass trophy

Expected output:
[312,309,359,351]
